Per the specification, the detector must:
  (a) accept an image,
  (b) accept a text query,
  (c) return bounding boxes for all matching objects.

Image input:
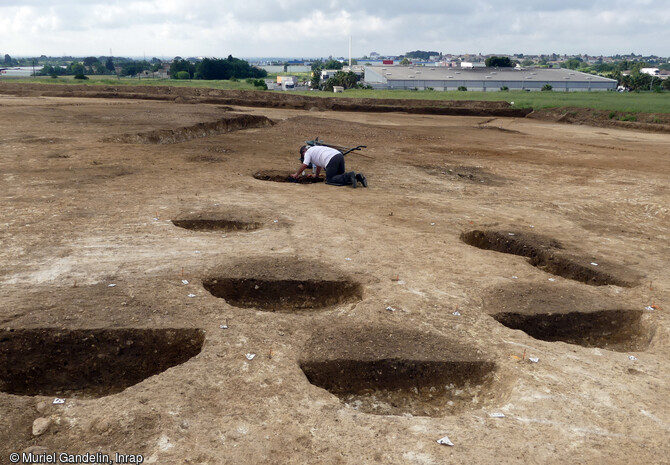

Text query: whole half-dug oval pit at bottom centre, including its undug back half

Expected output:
[300,327,505,417]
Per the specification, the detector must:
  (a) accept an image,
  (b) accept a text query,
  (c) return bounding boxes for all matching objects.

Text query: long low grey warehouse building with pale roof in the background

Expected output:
[365,66,617,92]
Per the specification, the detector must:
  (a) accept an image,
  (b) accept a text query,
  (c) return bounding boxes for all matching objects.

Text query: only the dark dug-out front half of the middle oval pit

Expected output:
[203,277,362,312]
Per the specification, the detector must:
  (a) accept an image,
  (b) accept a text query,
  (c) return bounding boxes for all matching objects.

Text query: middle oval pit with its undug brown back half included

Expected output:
[203,259,363,312]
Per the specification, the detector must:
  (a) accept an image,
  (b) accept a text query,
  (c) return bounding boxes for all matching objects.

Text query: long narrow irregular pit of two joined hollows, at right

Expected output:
[461,230,640,287]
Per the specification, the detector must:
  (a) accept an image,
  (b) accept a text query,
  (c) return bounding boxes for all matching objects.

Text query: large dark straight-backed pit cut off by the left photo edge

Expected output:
[0,328,205,398]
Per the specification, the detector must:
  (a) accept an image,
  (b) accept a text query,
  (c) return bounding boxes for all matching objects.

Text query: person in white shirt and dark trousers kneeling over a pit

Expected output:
[291,145,368,187]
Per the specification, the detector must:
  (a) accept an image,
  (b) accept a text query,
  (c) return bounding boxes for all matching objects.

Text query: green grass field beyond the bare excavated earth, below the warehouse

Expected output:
[0,76,670,113]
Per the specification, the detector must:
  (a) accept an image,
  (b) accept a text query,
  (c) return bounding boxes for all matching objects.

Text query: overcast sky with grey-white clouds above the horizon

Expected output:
[0,0,670,58]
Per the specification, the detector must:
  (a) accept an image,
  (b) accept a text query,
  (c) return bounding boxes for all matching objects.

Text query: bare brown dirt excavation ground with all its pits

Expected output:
[0,84,670,465]
